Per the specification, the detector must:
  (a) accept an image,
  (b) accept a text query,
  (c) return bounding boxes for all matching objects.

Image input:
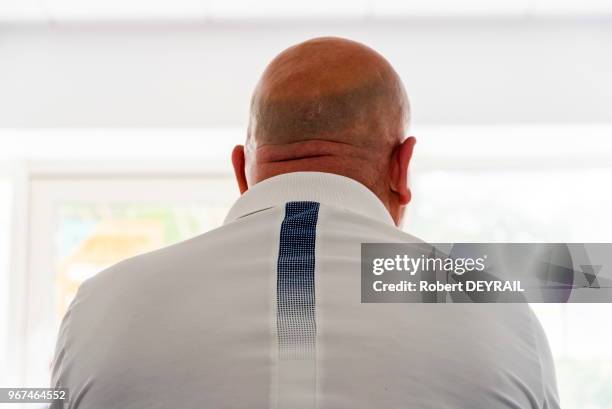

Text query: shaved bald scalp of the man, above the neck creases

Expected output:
[249,37,409,147]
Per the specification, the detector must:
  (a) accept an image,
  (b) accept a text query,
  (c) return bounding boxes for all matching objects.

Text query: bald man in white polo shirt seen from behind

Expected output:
[52,38,558,409]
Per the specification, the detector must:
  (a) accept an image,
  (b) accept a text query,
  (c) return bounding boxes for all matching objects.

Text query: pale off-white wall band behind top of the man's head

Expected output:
[0,19,612,127]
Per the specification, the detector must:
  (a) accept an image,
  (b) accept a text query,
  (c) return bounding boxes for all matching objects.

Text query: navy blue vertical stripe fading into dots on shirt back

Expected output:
[276,202,319,359]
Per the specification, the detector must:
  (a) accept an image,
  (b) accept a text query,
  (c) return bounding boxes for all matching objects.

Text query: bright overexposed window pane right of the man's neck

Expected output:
[405,166,612,409]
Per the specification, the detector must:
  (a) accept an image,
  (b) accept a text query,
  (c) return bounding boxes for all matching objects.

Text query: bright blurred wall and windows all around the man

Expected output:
[0,0,612,409]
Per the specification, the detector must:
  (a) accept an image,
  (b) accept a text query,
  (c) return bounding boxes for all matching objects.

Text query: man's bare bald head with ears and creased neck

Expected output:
[232,37,416,225]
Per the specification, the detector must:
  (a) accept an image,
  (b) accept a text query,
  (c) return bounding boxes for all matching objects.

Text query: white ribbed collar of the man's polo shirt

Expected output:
[224,172,394,225]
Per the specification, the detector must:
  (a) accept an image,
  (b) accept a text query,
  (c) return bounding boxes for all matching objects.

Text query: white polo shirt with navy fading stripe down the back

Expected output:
[52,172,559,409]
